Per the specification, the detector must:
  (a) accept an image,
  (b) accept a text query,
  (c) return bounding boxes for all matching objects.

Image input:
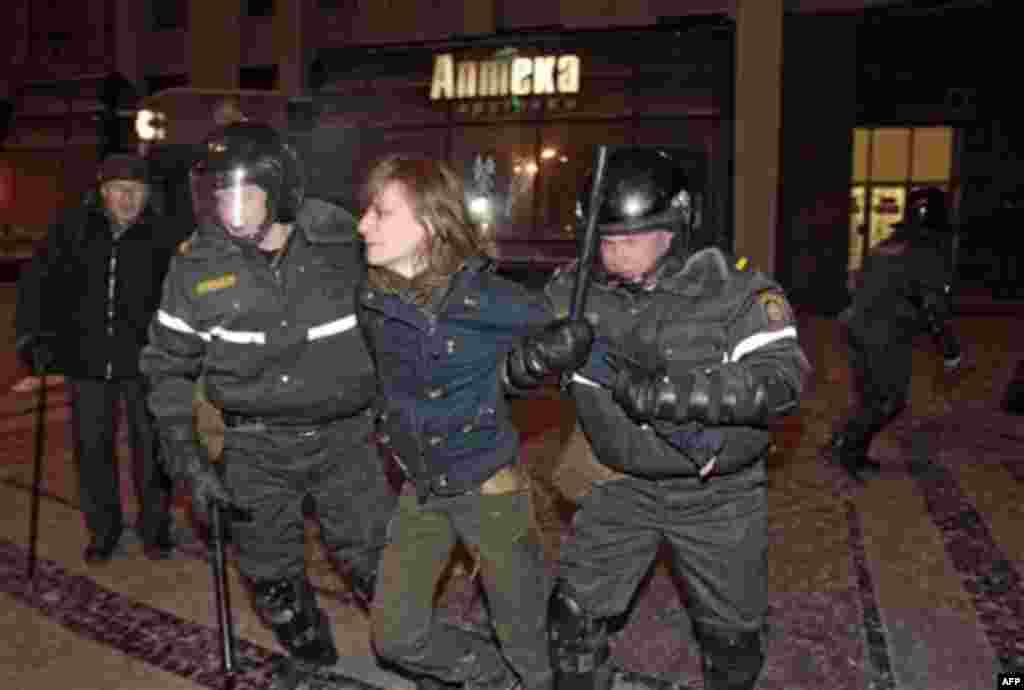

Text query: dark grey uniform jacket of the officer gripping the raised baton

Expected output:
[547,243,809,478]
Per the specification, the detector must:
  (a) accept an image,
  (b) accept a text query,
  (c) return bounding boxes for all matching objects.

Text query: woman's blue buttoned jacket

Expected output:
[359,258,551,500]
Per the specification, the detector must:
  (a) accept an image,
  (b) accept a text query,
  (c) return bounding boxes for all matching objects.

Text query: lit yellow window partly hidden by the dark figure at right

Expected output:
[849,127,955,270]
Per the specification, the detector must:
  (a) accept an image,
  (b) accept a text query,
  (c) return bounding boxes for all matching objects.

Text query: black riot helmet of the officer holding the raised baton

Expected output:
[577,147,698,236]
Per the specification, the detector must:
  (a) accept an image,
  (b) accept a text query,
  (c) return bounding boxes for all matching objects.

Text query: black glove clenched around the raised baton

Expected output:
[508,318,594,388]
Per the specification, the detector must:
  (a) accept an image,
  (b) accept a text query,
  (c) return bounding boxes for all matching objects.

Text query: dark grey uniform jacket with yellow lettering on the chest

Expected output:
[141,200,375,441]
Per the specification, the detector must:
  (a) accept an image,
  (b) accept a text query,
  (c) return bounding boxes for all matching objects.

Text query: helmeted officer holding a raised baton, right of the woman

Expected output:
[548,148,809,690]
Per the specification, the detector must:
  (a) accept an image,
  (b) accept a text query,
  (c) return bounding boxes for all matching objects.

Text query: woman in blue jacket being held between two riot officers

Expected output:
[357,155,593,690]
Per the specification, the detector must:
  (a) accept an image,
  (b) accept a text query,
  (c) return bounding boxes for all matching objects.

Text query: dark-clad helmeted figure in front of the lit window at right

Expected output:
[829,187,961,481]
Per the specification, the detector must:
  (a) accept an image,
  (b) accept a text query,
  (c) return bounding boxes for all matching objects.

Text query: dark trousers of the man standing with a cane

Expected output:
[71,379,171,544]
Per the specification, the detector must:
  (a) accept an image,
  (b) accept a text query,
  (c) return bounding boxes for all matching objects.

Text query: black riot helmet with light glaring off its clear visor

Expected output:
[190,122,305,245]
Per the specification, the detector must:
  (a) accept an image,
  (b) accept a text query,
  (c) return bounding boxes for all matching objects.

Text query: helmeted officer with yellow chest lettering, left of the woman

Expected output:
[136,122,395,687]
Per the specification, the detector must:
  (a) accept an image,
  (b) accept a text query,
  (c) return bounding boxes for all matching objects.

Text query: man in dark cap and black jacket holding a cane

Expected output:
[15,154,180,564]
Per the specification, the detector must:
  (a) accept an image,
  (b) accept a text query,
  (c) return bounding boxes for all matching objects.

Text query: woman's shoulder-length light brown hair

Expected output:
[364,154,493,304]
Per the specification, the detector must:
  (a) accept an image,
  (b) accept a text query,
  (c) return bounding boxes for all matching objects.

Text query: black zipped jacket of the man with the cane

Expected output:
[17,194,180,380]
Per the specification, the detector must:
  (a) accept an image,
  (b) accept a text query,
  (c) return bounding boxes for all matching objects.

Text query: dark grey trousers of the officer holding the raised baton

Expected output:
[559,460,768,690]
